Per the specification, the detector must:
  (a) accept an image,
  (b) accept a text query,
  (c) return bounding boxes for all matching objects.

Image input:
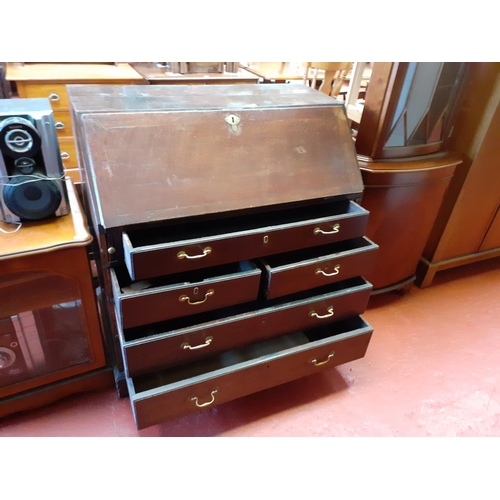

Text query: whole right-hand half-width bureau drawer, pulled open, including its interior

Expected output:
[261,237,378,299]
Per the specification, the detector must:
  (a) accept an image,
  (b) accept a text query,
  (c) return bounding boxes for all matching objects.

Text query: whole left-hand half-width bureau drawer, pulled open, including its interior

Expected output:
[111,261,261,328]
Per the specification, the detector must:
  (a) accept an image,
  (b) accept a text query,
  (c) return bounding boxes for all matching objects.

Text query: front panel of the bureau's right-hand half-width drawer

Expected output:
[264,238,378,299]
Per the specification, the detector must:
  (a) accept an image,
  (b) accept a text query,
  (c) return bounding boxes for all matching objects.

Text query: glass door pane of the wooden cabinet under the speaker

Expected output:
[0,272,92,387]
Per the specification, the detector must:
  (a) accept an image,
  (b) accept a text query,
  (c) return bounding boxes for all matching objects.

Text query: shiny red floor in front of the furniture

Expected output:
[0,259,500,437]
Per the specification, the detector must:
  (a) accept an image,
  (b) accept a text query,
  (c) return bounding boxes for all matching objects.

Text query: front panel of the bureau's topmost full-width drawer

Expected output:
[123,202,368,279]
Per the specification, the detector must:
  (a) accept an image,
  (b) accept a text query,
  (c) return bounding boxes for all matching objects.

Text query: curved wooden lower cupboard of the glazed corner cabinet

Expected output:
[359,153,462,293]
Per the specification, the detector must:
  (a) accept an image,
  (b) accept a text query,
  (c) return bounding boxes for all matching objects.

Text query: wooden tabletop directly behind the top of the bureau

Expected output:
[131,62,260,85]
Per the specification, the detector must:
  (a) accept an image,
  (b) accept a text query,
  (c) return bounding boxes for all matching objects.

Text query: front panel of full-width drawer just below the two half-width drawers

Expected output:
[120,280,372,376]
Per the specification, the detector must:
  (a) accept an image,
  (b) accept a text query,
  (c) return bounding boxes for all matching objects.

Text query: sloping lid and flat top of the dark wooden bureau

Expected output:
[67,84,363,229]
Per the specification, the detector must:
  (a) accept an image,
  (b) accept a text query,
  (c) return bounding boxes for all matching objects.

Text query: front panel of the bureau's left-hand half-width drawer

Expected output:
[111,266,261,328]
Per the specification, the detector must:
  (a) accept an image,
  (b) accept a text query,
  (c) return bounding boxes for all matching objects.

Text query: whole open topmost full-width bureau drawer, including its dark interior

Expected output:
[122,201,369,280]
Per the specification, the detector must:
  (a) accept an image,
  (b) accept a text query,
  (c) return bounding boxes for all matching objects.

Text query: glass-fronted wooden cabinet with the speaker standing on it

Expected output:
[0,179,112,417]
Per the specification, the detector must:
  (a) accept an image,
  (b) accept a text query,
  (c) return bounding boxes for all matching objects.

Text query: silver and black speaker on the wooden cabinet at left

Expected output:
[0,99,69,222]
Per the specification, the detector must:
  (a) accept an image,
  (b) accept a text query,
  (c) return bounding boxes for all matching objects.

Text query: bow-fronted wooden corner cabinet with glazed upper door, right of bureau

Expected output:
[356,62,466,292]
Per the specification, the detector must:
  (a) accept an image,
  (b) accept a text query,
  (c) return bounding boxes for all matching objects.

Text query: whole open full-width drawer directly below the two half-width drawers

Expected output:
[117,278,372,376]
